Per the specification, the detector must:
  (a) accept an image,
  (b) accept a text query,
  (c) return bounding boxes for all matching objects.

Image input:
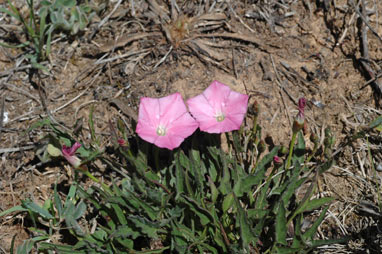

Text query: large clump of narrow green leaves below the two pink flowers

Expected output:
[0,114,350,253]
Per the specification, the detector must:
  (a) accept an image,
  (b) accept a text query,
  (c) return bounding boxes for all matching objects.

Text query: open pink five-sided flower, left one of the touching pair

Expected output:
[136,93,198,150]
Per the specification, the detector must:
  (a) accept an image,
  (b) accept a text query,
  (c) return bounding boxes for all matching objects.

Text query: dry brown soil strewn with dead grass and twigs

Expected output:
[0,0,382,253]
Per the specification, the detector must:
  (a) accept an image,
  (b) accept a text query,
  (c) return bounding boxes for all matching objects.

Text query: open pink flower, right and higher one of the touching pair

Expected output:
[187,80,248,133]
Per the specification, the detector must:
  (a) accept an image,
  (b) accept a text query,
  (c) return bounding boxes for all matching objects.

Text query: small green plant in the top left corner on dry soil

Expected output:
[0,0,95,69]
